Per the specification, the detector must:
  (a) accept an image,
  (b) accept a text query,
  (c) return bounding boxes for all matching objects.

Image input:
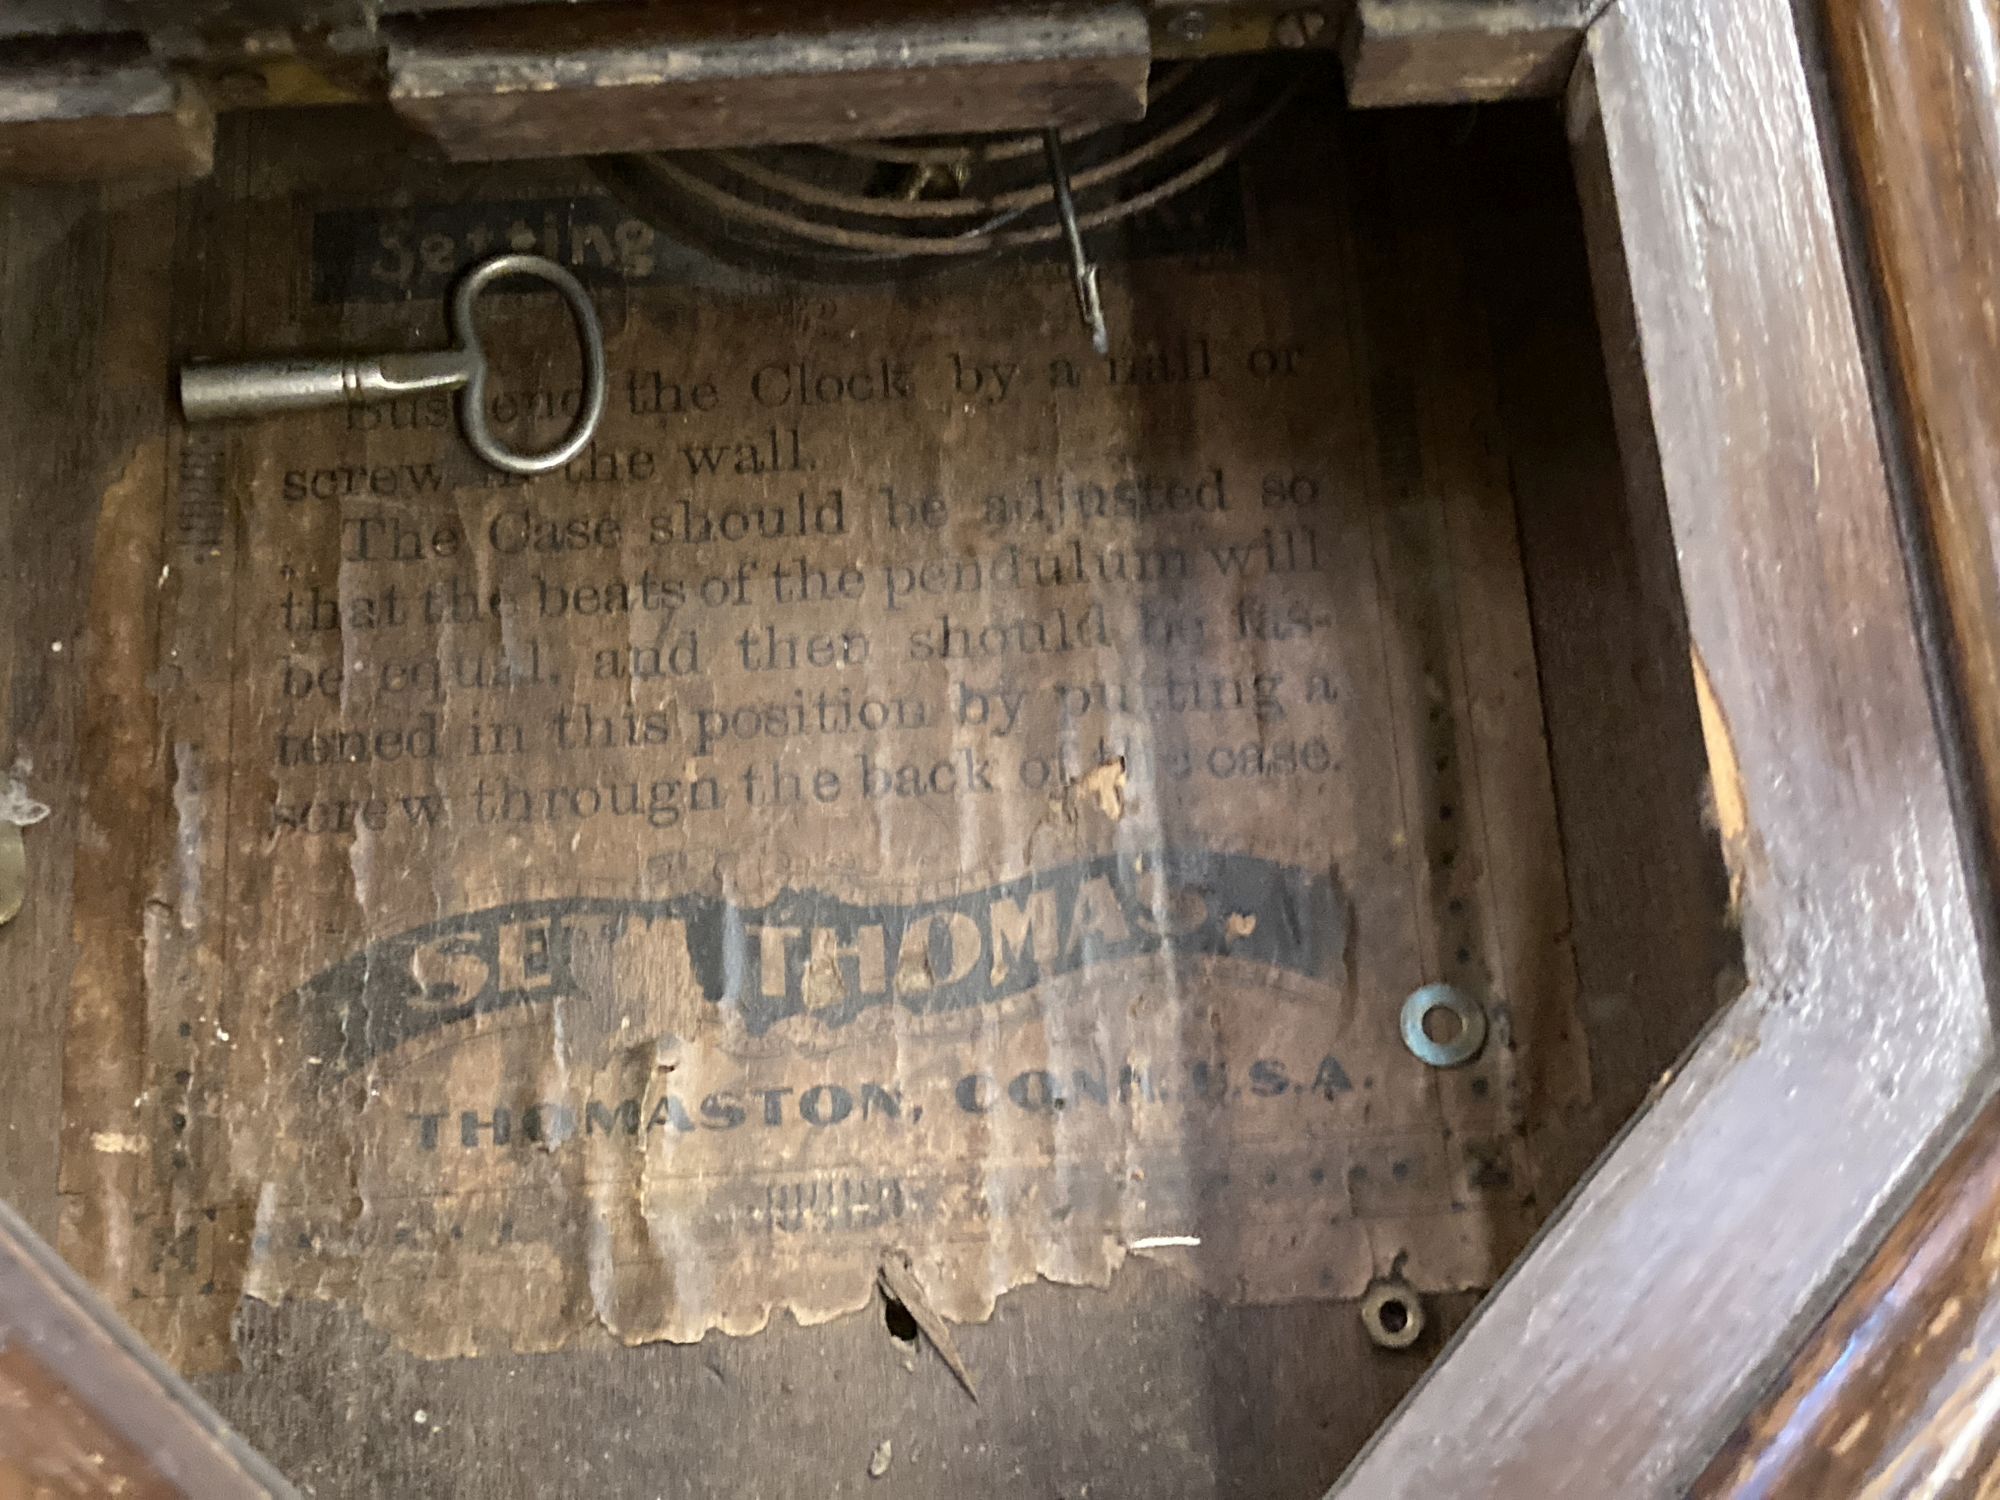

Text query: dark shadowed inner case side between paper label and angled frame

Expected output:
[1464,112,1742,1188]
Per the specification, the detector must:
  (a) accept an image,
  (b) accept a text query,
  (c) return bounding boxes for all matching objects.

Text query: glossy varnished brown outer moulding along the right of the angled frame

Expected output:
[1700,0,2000,1496]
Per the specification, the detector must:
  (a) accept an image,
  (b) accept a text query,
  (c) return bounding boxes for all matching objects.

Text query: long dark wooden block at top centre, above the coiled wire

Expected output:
[388,0,1152,160]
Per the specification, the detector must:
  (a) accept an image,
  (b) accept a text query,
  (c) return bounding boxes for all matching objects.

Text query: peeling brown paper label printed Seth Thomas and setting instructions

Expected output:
[68,159,1586,1368]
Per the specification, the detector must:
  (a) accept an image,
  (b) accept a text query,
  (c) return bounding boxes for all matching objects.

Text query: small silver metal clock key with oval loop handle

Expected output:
[180,254,604,474]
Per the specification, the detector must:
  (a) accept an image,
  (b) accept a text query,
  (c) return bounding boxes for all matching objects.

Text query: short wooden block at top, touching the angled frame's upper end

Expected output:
[1342,0,1604,108]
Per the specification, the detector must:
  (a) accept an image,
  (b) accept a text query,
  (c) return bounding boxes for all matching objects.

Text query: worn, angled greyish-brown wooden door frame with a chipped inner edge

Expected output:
[1344,0,1994,1500]
